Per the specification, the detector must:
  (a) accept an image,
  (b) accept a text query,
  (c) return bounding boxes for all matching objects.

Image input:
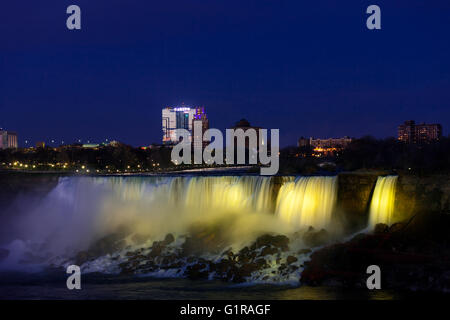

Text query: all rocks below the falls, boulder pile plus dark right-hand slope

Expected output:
[67,214,450,292]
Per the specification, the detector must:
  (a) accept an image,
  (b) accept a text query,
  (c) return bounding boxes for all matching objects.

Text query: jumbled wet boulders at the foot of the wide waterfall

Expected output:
[69,229,311,283]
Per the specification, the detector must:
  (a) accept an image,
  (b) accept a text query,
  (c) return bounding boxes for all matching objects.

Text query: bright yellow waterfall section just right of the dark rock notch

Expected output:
[276,177,337,228]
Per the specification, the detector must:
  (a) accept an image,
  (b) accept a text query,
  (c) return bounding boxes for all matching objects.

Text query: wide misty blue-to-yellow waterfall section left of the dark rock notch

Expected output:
[0,176,286,262]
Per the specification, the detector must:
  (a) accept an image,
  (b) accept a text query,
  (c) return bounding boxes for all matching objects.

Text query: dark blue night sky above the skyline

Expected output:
[0,0,450,146]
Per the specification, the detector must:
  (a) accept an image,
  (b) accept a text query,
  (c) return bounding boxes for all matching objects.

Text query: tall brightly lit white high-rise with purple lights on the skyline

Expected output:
[162,104,207,144]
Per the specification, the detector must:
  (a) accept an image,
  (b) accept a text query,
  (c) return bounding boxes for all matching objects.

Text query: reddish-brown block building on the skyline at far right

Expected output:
[398,120,442,144]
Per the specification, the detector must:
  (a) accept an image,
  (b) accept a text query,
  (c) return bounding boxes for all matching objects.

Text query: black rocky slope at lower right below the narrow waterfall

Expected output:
[300,214,450,292]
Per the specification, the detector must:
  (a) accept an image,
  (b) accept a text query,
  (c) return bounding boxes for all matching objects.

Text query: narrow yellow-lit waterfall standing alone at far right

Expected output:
[369,176,398,228]
